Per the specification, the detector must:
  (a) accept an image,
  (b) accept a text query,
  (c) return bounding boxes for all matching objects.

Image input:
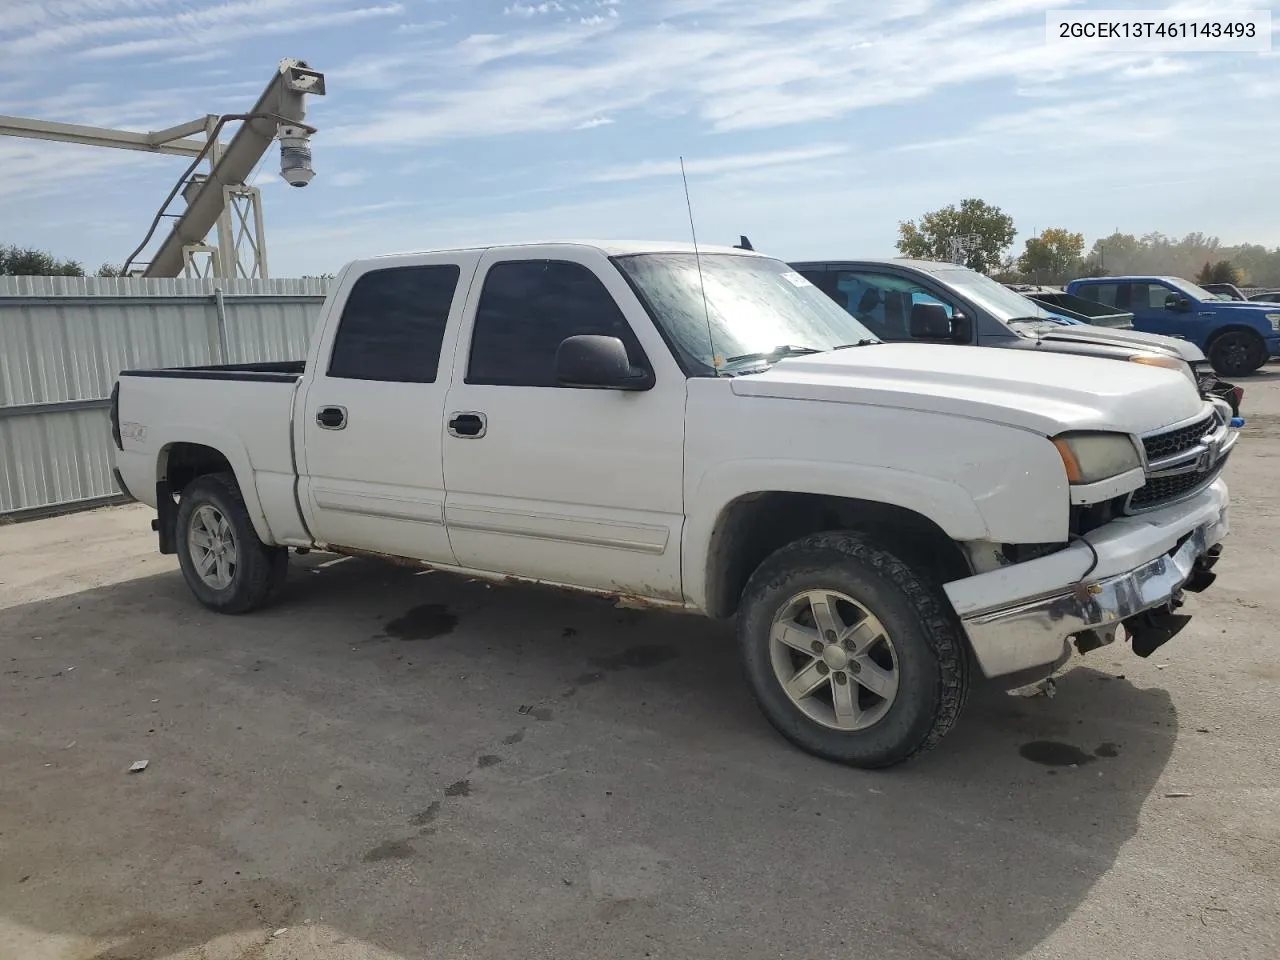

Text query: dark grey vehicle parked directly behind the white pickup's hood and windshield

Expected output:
[792,259,1244,415]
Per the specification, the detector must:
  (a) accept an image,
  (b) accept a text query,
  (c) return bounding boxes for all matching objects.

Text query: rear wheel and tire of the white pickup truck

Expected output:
[174,474,289,613]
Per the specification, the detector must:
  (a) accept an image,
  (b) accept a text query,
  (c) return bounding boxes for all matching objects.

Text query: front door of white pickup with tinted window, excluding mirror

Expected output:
[443,244,686,599]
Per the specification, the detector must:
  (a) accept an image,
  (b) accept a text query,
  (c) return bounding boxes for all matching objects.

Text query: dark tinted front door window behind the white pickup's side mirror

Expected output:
[467,260,644,387]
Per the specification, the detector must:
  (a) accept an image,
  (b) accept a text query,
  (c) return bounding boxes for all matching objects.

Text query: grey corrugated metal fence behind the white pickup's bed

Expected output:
[0,276,329,517]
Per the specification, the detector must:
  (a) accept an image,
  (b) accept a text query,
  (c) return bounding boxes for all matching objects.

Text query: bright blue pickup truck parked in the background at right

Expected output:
[1066,276,1280,376]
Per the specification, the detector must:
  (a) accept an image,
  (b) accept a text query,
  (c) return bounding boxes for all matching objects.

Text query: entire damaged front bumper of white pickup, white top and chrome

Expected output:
[945,479,1228,677]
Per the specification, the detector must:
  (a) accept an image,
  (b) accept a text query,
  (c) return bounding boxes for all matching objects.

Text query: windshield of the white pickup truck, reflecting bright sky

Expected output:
[613,253,878,372]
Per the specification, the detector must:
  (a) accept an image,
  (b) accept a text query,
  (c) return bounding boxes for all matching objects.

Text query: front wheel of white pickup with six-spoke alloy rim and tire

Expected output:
[739,532,969,768]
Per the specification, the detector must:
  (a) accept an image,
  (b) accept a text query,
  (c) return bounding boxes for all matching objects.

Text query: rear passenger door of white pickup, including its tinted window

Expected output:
[296,255,479,563]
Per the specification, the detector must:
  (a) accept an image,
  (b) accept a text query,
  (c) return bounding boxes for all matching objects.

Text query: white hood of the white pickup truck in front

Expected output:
[732,343,1203,436]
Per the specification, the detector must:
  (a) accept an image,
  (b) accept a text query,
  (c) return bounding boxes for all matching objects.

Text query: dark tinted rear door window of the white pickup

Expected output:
[329,264,461,383]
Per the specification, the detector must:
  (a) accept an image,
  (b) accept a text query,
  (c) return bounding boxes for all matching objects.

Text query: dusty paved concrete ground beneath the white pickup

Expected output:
[0,371,1280,960]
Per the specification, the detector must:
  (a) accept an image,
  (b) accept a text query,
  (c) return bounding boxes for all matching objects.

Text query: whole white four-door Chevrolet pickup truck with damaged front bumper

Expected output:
[111,243,1238,767]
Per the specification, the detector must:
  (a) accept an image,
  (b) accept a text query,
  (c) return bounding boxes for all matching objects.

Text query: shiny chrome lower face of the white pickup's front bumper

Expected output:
[961,511,1226,677]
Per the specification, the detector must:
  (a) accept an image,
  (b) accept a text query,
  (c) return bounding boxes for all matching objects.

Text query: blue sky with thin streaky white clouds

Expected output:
[0,0,1280,276]
